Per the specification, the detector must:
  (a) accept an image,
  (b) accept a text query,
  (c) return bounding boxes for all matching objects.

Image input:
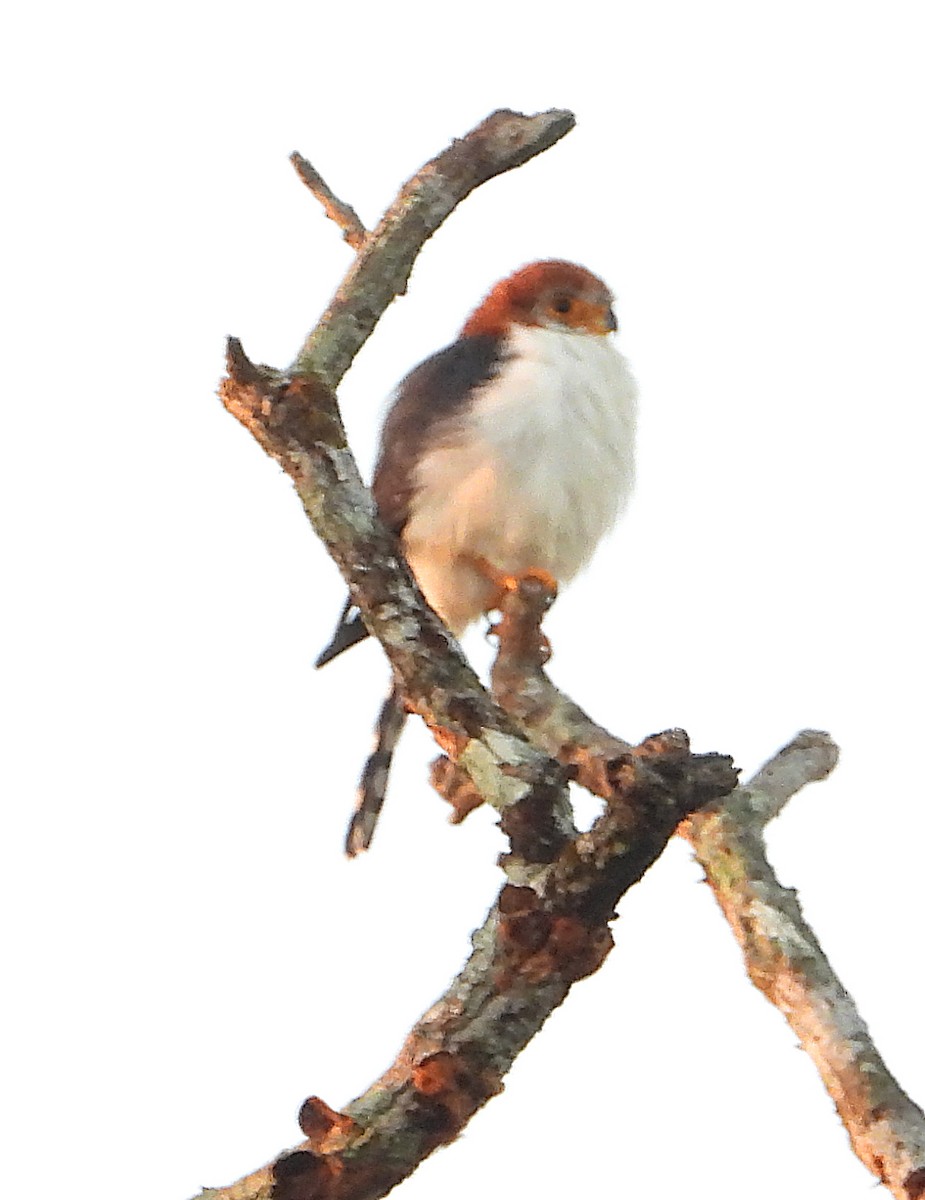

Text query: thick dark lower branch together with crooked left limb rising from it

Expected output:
[211,113,735,1200]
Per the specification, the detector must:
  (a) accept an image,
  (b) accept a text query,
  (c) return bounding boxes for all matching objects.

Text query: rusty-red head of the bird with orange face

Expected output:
[463,259,617,337]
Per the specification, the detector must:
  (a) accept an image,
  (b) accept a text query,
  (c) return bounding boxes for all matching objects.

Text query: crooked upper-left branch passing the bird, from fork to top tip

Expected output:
[220,110,575,862]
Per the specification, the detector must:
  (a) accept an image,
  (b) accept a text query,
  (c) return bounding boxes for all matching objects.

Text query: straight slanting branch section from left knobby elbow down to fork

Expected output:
[221,360,573,863]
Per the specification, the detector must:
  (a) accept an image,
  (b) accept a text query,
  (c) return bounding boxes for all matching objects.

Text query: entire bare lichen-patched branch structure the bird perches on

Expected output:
[202,110,925,1200]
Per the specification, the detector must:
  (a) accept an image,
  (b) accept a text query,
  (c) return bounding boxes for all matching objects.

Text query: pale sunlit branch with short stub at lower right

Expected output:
[681,731,925,1200]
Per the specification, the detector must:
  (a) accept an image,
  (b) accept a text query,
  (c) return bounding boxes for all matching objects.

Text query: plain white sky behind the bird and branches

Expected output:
[0,0,925,1200]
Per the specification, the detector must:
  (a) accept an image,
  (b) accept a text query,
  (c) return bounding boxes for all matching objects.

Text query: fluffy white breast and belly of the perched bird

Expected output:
[403,326,636,630]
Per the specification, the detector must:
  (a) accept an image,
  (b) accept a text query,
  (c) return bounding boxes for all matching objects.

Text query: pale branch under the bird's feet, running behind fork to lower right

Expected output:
[470,581,925,1200]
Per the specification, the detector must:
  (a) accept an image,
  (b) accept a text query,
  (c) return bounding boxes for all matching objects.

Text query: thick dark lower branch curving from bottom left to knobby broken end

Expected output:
[199,732,735,1200]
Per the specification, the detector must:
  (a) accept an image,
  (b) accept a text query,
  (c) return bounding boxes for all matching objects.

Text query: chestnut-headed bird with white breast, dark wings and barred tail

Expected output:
[316,259,637,857]
